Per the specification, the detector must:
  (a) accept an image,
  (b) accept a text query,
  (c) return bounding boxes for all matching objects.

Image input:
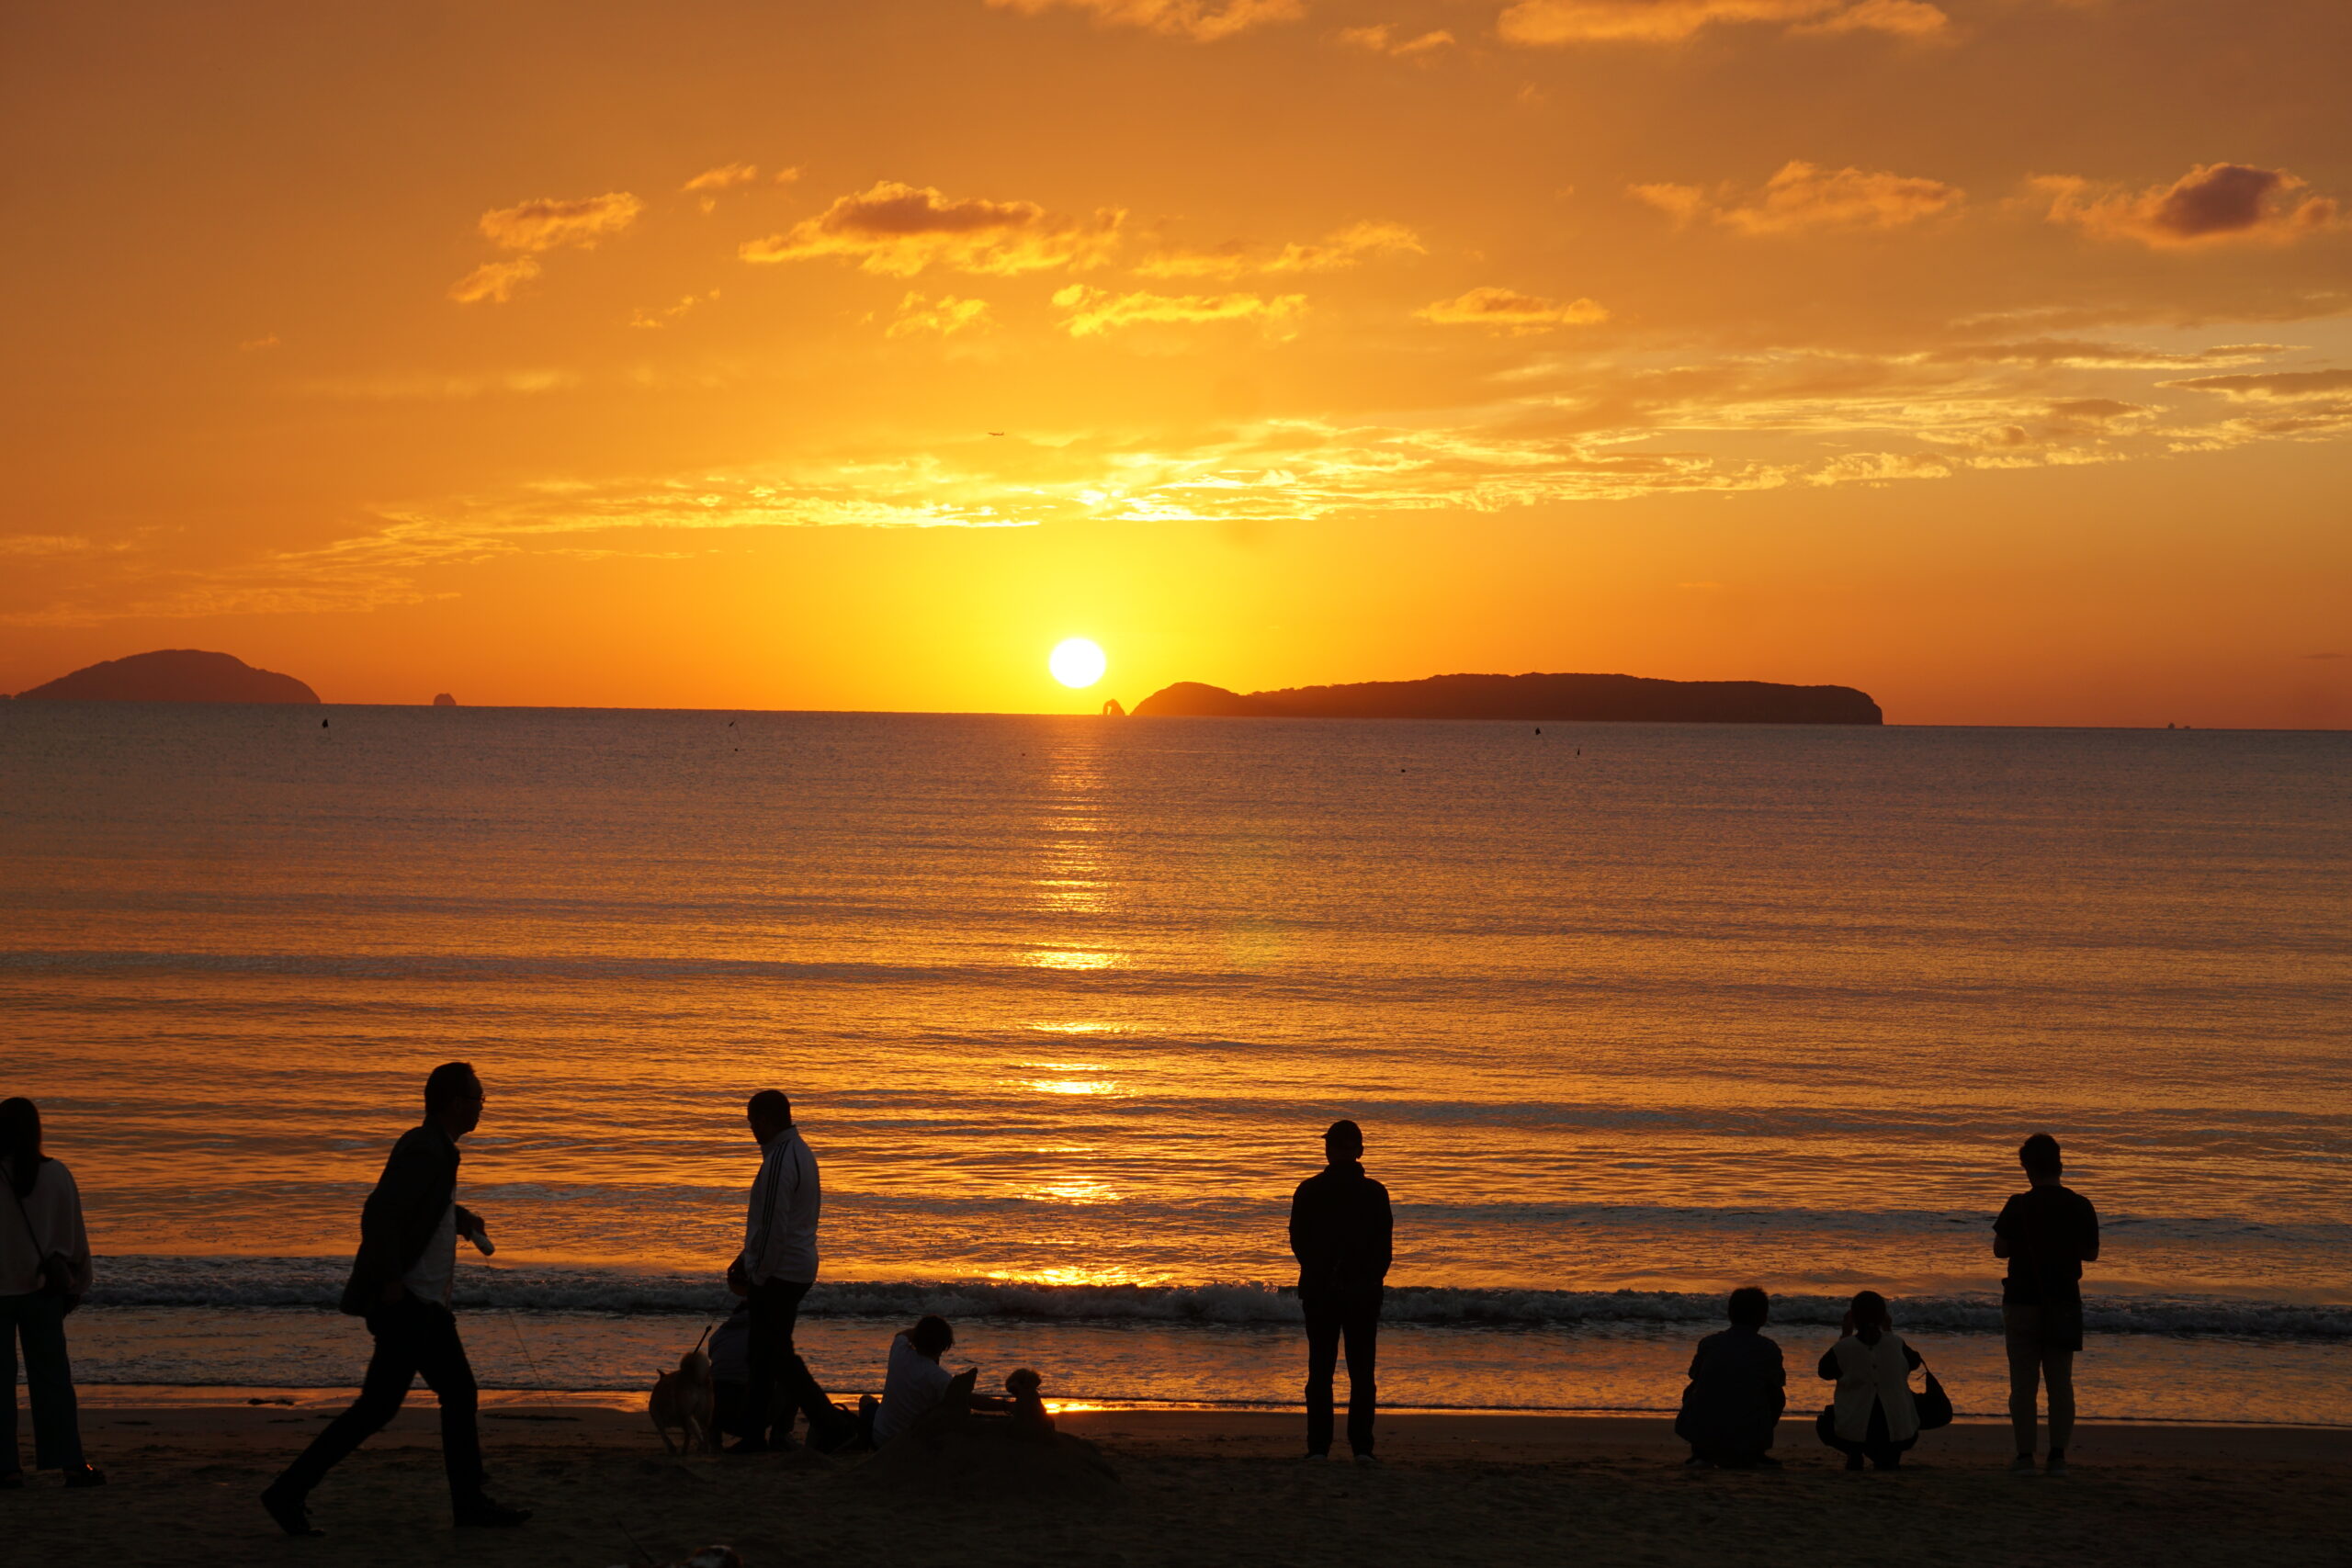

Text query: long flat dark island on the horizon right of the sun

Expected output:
[1136,674,1886,724]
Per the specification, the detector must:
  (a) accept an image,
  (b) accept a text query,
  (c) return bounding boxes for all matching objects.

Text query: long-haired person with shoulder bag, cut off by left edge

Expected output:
[0,1096,106,1488]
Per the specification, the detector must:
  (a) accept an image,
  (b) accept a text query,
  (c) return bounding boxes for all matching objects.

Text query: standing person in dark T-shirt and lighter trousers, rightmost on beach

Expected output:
[1992,1134,2098,1476]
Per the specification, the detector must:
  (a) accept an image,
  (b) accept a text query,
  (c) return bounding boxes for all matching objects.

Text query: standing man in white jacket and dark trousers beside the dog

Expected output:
[727,1089,856,1453]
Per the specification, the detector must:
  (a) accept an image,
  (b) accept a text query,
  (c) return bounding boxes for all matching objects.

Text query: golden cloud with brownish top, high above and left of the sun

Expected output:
[739,179,1126,277]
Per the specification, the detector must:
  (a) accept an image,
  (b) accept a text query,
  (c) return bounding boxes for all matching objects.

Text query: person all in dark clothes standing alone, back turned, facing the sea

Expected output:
[1291,1122,1395,1464]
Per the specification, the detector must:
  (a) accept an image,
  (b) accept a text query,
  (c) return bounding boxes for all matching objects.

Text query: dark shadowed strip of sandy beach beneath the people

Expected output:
[0,1396,2352,1568]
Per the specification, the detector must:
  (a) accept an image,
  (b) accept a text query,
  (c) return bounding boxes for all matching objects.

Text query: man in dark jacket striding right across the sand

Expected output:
[261,1063,532,1535]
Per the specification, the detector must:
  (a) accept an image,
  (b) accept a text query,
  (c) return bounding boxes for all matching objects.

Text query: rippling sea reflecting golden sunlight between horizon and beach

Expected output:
[0,703,2352,1417]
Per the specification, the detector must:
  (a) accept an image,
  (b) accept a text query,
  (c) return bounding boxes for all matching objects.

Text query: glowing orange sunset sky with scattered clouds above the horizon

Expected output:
[0,0,2352,727]
